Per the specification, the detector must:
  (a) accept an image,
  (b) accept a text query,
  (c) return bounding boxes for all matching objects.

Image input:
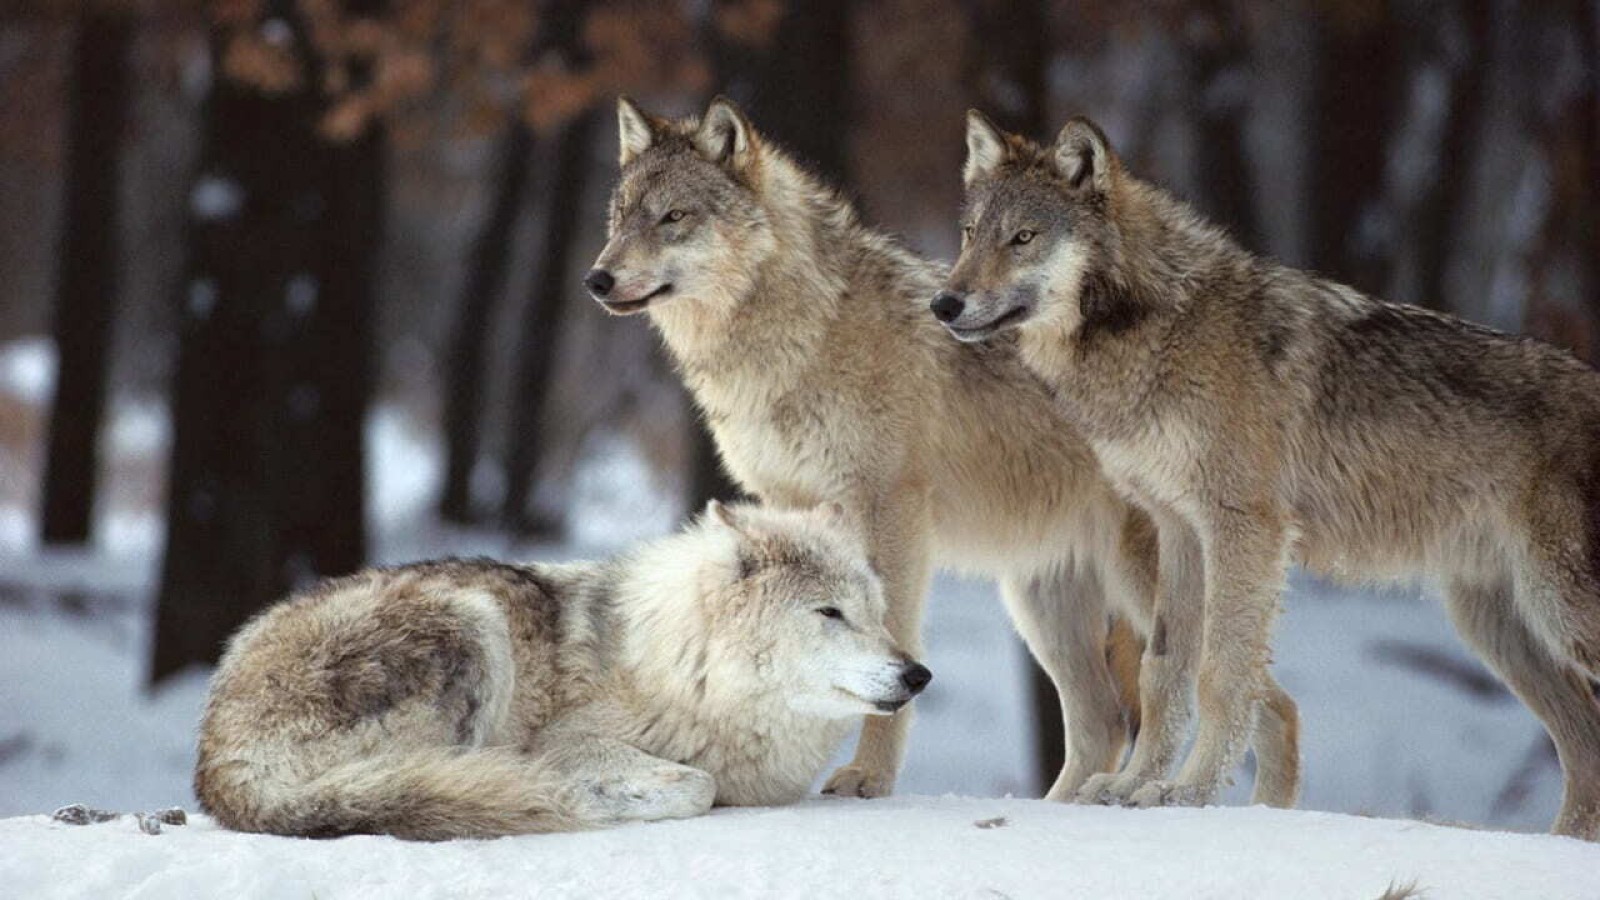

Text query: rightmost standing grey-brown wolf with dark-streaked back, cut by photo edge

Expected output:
[933,114,1600,839]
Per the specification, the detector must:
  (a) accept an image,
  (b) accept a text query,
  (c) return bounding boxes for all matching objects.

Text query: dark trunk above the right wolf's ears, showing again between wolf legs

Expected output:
[970,0,1067,788]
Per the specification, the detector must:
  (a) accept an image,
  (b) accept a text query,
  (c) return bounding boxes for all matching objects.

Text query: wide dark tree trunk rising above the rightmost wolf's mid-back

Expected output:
[1310,3,1403,293]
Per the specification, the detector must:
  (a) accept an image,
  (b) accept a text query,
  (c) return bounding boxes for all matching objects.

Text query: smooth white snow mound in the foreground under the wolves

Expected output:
[0,798,1600,900]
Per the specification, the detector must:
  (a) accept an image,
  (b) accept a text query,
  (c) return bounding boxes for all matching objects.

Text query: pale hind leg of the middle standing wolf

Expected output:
[1000,569,1126,801]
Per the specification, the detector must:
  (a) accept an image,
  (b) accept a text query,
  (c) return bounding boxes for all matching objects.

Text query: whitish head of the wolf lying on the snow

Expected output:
[699,501,933,717]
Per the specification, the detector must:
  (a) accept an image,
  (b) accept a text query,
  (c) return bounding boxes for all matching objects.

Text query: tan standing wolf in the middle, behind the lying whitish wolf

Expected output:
[586,99,1299,806]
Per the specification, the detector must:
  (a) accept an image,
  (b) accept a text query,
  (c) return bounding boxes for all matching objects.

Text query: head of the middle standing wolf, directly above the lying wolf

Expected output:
[584,98,774,315]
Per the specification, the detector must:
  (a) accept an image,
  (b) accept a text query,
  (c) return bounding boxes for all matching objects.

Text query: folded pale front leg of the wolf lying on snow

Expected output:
[539,737,717,826]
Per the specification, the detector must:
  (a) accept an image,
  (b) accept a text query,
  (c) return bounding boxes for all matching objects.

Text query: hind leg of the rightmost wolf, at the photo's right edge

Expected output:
[1445,570,1600,841]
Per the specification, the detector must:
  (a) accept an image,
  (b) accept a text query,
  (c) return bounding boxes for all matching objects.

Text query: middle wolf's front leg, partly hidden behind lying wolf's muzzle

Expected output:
[822,480,933,798]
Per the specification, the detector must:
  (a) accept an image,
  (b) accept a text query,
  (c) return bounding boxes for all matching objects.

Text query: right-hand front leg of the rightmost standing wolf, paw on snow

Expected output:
[1131,500,1288,806]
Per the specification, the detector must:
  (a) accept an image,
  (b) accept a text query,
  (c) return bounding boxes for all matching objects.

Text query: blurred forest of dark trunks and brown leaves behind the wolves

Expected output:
[0,0,1600,813]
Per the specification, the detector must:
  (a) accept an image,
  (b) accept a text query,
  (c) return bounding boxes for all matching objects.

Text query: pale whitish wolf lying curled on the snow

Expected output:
[195,503,931,839]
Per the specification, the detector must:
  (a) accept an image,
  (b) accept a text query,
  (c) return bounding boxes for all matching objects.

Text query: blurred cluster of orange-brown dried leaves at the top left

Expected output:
[206,0,784,141]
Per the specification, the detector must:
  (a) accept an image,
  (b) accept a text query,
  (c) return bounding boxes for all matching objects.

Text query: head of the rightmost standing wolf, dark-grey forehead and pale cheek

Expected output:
[930,110,1123,341]
